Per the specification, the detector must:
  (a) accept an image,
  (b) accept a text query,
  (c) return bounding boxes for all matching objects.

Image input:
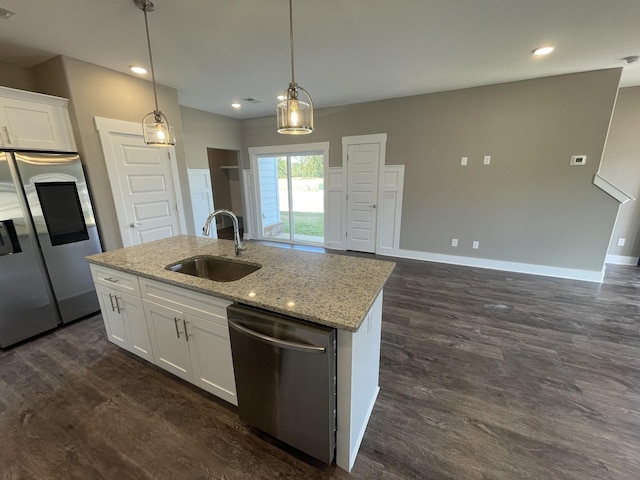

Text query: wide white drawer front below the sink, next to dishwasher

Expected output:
[140,278,233,326]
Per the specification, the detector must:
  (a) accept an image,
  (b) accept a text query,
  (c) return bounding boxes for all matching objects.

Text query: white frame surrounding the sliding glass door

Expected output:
[242,142,330,245]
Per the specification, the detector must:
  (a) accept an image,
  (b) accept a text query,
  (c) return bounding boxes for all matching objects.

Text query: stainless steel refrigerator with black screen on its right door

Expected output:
[0,151,102,348]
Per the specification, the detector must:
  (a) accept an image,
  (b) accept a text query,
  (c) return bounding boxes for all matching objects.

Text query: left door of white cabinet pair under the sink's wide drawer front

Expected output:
[144,300,193,382]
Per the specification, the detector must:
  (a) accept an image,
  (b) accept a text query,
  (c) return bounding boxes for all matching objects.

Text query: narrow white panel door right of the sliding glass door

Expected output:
[347,143,380,253]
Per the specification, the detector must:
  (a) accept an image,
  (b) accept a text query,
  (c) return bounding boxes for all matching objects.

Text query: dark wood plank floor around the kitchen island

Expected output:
[0,253,640,480]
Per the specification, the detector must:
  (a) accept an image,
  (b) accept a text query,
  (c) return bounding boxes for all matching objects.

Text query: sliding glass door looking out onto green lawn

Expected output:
[255,151,325,245]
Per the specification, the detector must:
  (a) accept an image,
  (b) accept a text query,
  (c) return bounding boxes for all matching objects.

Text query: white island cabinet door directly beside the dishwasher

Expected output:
[185,314,238,405]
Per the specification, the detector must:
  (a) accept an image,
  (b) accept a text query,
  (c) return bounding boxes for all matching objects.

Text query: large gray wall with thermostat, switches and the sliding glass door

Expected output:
[243,69,621,271]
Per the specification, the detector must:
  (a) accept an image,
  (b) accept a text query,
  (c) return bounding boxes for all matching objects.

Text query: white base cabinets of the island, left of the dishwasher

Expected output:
[91,265,238,405]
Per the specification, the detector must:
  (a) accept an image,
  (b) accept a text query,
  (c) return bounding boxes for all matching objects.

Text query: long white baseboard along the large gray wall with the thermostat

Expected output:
[387,249,604,283]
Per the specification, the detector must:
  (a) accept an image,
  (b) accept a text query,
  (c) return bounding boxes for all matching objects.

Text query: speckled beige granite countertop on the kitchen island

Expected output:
[87,235,395,332]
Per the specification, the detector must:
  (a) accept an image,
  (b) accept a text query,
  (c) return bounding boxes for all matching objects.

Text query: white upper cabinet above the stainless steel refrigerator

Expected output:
[0,87,77,152]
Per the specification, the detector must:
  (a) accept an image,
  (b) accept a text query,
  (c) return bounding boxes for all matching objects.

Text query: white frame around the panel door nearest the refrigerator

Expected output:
[93,117,187,247]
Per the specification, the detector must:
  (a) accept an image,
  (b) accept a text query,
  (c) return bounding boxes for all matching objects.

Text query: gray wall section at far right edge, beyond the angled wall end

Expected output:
[601,87,640,259]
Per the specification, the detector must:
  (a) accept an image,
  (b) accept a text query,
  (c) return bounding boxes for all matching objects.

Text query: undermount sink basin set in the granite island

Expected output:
[169,255,262,282]
